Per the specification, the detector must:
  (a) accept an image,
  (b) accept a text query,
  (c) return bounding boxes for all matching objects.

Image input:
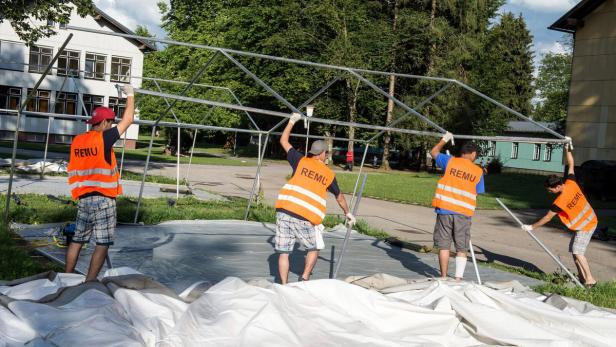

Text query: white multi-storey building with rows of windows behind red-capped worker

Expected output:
[0,9,156,148]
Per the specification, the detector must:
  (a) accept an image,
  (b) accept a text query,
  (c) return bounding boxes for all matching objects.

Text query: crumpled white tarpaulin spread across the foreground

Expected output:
[0,269,616,347]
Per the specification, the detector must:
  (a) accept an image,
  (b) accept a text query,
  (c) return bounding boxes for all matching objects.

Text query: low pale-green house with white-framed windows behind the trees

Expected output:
[477,121,564,174]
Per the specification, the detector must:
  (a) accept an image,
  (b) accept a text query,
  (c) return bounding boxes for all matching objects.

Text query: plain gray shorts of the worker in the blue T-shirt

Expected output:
[434,214,471,252]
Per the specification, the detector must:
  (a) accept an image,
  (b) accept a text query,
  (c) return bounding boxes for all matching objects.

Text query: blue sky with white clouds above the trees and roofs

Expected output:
[94,0,579,69]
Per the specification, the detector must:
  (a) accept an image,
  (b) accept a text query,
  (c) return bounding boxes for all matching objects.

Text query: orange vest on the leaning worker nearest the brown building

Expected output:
[554,180,598,232]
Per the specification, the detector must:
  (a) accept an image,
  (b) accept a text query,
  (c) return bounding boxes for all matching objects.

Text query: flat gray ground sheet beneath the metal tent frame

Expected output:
[14,220,540,292]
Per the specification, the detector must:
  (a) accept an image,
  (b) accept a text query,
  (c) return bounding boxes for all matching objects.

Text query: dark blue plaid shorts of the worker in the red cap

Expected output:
[73,196,117,246]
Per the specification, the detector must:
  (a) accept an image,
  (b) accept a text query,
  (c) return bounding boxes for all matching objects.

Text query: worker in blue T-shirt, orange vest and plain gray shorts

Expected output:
[430,132,485,281]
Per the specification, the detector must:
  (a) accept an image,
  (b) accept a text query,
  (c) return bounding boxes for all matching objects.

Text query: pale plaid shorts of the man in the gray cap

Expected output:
[274,212,317,253]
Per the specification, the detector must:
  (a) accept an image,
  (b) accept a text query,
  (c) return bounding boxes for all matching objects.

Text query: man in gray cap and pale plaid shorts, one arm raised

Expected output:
[274,113,355,284]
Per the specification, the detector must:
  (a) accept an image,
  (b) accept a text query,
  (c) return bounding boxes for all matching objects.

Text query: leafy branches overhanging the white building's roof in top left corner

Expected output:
[0,0,94,45]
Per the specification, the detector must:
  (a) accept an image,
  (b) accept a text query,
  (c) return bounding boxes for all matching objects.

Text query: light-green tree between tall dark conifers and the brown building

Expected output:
[533,47,572,122]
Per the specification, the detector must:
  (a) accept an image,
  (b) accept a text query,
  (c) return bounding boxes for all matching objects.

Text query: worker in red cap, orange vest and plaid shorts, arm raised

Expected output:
[65,84,135,281]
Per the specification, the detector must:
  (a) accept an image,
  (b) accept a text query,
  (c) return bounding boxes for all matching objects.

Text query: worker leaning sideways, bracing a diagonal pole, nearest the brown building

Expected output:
[522,137,598,288]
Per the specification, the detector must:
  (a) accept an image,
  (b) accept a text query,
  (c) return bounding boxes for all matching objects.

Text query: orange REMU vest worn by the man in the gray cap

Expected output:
[276,157,336,225]
